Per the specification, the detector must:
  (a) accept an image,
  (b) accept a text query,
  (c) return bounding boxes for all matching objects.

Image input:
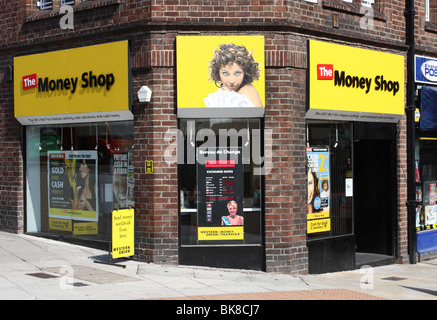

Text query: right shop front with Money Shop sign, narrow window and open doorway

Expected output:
[306,40,404,273]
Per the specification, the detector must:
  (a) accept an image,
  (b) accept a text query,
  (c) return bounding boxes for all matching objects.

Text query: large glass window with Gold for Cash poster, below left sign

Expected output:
[26,122,134,240]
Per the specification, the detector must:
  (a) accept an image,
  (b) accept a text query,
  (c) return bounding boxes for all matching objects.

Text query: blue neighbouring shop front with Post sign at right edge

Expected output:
[415,56,437,261]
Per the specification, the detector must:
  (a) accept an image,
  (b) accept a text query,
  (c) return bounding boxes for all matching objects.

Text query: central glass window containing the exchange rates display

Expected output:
[178,119,262,245]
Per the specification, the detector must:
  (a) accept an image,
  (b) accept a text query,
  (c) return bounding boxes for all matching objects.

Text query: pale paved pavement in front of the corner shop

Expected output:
[0,231,437,300]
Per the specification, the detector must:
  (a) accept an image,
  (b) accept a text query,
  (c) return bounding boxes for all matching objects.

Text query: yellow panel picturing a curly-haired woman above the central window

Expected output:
[176,36,265,118]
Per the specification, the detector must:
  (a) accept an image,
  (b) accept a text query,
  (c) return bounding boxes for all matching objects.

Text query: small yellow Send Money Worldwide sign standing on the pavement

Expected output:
[112,209,135,259]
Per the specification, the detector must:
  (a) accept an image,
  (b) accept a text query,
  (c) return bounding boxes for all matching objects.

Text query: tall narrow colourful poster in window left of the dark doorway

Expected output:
[307,147,330,233]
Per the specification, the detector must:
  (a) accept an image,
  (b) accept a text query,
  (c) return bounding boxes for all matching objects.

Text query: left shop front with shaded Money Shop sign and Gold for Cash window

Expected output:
[14,41,134,248]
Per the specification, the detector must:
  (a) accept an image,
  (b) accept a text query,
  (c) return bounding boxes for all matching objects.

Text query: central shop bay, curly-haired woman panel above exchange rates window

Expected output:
[176,36,265,270]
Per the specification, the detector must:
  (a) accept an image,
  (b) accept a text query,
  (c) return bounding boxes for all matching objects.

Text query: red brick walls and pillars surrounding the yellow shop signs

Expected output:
[0,0,437,274]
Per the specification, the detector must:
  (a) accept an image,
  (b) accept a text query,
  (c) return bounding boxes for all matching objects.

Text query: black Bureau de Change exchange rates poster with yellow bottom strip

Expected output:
[197,147,244,240]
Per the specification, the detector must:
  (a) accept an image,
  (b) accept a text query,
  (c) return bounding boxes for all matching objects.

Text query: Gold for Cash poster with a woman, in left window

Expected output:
[47,150,99,221]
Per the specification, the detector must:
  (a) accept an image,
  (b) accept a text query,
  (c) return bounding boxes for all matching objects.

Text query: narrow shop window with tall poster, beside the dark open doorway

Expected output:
[307,122,353,239]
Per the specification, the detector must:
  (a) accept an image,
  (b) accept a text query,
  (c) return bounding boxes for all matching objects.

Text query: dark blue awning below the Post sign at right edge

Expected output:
[420,86,437,130]
